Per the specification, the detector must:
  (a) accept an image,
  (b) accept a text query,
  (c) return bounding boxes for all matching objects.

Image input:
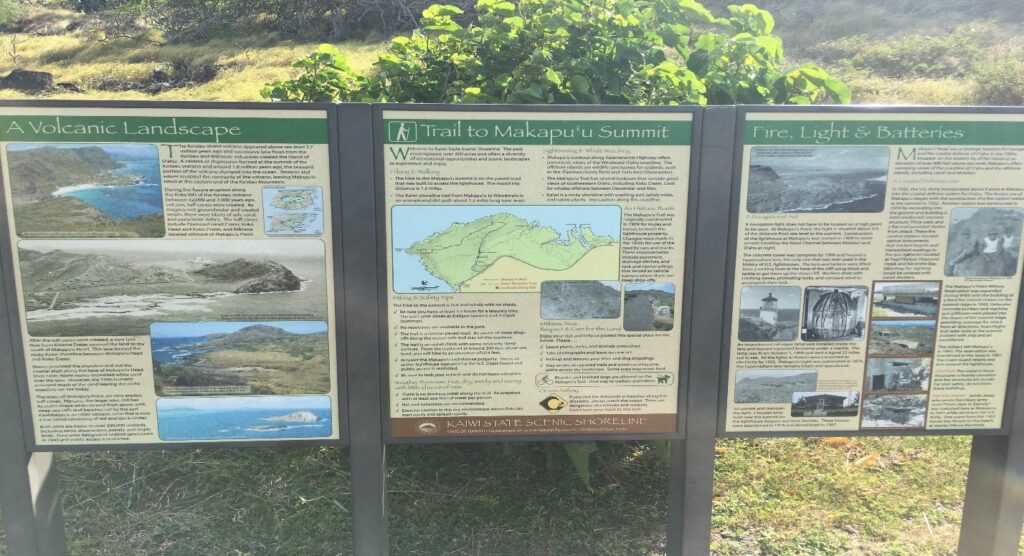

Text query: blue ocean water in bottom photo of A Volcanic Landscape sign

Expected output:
[157,405,332,440]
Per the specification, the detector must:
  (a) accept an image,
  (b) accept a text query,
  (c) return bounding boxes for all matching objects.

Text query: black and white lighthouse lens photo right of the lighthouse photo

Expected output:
[800,286,867,342]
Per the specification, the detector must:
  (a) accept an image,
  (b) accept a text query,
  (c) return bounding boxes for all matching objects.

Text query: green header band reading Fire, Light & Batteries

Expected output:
[743,120,1024,145]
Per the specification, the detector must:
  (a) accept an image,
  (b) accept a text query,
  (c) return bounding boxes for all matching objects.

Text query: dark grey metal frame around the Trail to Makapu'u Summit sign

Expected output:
[373,103,702,443]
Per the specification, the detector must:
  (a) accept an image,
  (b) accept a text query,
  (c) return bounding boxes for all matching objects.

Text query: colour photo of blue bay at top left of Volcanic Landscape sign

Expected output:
[7,143,165,238]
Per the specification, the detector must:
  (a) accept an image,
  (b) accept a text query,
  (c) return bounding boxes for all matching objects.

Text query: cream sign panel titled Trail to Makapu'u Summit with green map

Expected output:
[381,110,692,438]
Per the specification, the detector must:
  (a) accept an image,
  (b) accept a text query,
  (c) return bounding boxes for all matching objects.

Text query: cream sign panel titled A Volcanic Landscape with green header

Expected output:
[0,105,339,446]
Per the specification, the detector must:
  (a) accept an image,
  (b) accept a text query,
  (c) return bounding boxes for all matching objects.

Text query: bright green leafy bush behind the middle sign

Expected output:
[262,0,850,104]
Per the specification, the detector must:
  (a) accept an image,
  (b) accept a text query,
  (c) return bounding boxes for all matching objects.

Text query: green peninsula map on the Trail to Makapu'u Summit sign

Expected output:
[395,207,620,293]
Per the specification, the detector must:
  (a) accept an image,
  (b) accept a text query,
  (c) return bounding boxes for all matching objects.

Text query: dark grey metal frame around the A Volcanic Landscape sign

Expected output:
[0,100,350,452]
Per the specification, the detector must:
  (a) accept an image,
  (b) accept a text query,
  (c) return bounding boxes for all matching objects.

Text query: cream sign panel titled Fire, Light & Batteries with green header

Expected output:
[725,112,1024,432]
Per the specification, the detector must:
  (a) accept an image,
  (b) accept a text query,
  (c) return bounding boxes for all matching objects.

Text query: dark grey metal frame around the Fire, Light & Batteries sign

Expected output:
[718,105,1024,438]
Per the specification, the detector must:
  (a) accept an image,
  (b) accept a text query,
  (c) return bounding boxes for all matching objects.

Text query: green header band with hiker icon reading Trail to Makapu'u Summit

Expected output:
[384,118,692,146]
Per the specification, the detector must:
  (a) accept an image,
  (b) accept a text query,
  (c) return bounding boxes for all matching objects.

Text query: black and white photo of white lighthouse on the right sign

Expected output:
[738,286,800,342]
